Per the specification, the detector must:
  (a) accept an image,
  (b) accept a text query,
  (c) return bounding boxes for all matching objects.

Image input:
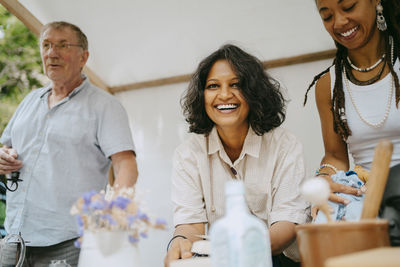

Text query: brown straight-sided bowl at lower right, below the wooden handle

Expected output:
[296,219,390,267]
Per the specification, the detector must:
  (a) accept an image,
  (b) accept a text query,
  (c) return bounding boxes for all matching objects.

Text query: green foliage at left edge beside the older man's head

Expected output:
[0,5,43,135]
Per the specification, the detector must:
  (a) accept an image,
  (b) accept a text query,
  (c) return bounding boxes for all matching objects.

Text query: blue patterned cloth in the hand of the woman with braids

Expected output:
[314,171,364,223]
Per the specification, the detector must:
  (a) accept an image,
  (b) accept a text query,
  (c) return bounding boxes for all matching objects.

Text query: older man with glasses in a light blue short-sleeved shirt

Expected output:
[0,22,137,267]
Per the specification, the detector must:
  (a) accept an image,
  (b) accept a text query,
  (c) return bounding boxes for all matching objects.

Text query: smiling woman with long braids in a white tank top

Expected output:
[304,0,400,207]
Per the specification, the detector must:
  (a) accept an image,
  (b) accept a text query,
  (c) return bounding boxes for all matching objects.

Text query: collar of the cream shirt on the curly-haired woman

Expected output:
[208,126,262,159]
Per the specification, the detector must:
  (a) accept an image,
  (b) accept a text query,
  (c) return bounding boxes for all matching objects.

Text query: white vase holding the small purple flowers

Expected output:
[78,231,141,267]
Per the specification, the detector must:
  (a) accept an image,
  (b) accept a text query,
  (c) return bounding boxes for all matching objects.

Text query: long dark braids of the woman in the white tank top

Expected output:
[303,0,400,140]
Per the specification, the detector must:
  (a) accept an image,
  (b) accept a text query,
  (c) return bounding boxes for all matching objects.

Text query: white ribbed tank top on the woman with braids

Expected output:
[330,60,400,169]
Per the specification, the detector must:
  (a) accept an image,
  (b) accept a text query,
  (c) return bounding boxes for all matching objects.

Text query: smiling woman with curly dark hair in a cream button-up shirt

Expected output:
[165,44,309,266]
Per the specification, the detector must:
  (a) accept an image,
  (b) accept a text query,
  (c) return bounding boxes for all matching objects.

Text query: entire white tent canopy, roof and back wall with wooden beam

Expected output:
[0,0,334,266]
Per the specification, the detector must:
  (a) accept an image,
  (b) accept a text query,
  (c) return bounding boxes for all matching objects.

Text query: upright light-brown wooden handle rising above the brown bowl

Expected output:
[361,140,393,219]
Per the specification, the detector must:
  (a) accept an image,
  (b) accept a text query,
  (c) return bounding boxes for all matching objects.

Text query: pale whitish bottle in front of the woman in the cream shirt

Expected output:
[210,180,272,267]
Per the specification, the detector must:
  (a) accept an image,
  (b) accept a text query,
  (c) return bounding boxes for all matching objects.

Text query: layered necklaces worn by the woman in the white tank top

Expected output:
[343,37,394,128]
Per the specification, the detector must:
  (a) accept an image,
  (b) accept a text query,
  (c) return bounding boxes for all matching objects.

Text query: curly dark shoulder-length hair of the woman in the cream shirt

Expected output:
[181,44,286,135]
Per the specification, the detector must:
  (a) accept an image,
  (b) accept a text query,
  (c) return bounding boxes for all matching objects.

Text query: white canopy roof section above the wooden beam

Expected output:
[4,0,334,90]
